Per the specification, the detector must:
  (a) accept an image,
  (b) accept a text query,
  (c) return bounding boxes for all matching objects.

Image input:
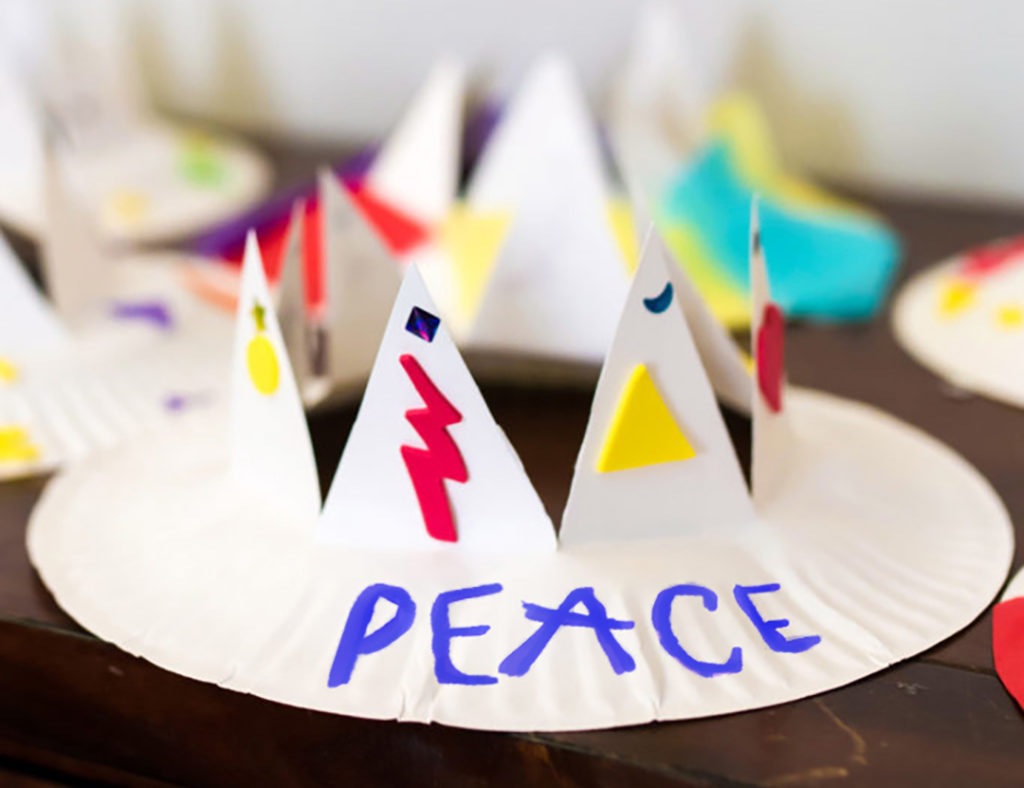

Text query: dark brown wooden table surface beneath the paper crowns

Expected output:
[0,150,1024,788]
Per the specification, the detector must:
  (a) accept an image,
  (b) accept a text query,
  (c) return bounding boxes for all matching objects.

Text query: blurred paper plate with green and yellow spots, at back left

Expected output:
[0,123,271,243]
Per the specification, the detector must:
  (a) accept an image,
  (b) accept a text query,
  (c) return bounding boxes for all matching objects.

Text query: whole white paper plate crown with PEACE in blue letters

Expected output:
[29,198,1012,730]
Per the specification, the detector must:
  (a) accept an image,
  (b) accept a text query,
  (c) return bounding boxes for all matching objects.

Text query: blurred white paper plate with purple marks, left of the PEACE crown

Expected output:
[0,253,233,480]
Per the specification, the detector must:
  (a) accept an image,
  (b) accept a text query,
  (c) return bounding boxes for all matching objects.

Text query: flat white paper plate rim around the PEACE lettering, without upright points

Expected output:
[28,391,1013,730]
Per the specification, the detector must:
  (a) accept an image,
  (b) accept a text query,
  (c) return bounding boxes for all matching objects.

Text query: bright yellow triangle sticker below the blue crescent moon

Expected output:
[597,364,696,473]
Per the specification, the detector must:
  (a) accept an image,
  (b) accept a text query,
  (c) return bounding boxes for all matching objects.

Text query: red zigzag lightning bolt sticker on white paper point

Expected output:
[398,353,469,541]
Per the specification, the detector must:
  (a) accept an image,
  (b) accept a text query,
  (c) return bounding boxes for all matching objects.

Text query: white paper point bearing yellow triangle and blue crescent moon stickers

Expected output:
[560,227,754,545]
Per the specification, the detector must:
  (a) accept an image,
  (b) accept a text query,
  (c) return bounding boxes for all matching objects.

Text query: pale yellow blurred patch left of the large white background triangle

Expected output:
[437,205,509,322]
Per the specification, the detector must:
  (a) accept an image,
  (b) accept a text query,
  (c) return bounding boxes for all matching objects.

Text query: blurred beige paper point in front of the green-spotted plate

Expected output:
[42,144,113,320]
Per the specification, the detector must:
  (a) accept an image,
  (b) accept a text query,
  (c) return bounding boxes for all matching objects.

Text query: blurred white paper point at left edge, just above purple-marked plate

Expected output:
[0,234,69,358]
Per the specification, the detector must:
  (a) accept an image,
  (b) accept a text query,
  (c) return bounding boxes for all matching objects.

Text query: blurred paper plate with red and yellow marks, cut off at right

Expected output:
[893,242,1024,406]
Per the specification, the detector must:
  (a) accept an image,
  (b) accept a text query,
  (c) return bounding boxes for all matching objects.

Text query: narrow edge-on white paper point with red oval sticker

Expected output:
[750,199,790,510]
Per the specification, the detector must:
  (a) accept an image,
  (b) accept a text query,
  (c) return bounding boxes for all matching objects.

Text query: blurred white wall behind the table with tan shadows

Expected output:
[22,0,1024,202]
